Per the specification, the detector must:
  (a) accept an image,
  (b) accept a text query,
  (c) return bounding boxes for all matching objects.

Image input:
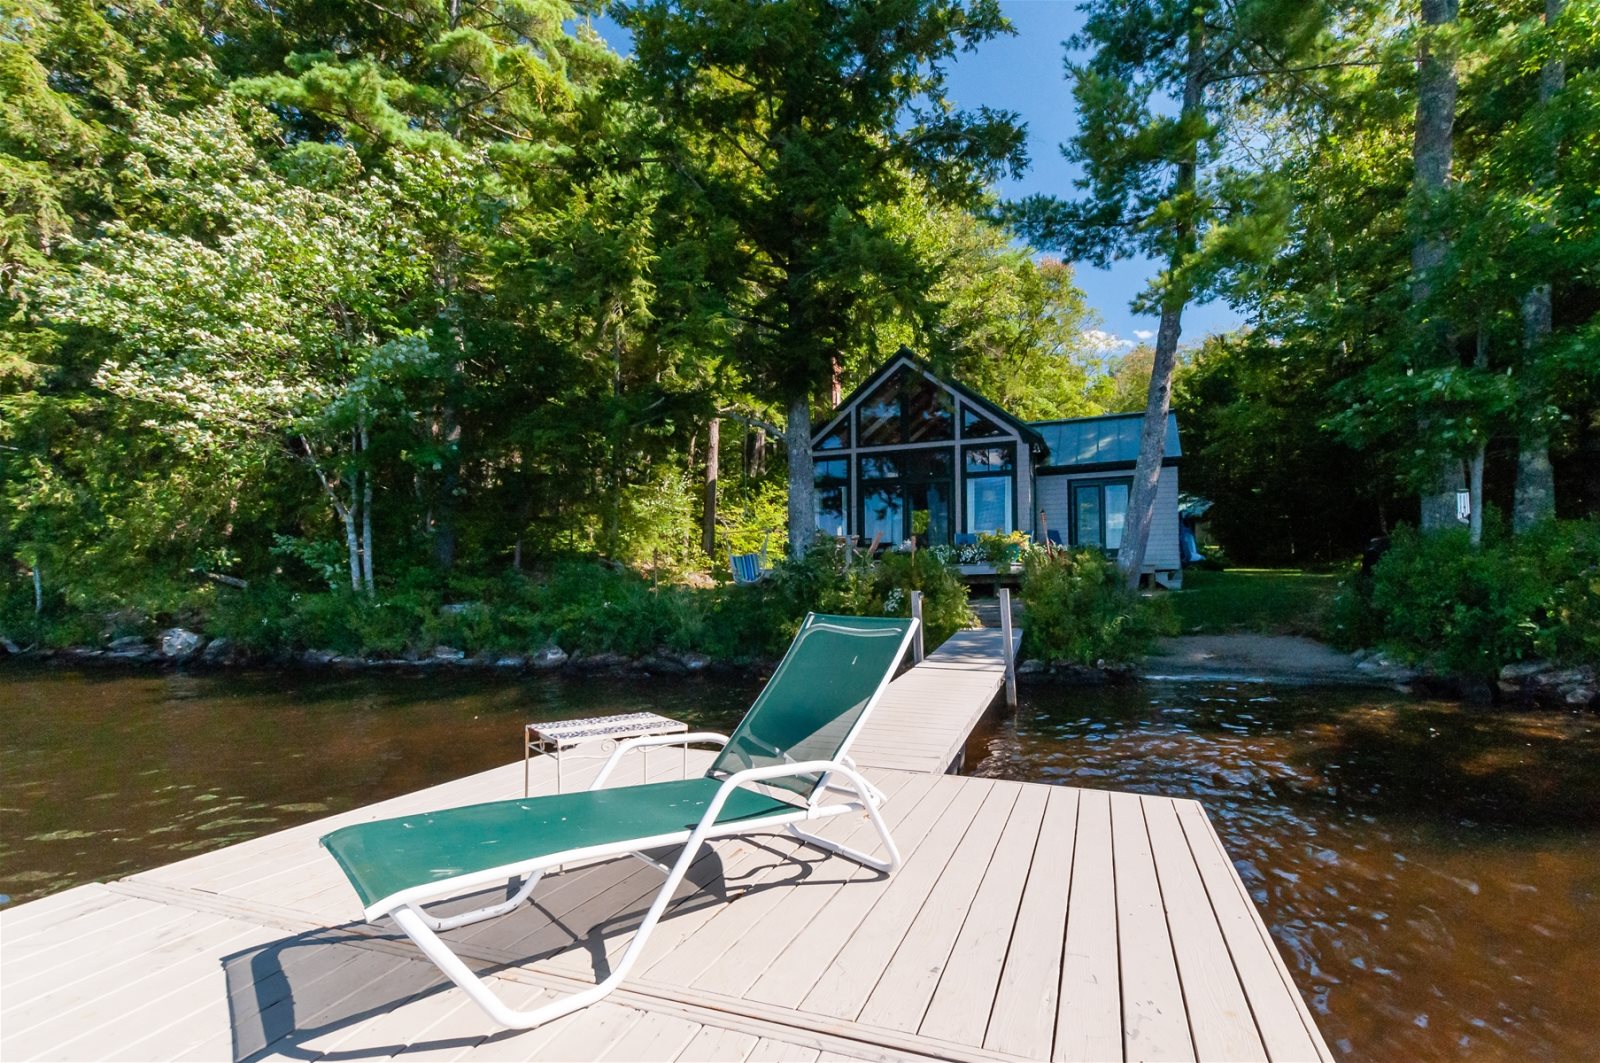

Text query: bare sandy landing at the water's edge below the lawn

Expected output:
[1139,634,1411,685]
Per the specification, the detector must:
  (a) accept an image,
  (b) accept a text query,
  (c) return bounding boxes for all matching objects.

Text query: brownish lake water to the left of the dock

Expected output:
[0,666,754,901]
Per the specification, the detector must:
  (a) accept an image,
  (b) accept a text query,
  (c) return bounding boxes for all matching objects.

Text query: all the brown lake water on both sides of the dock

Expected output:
[0,666,1600,1060]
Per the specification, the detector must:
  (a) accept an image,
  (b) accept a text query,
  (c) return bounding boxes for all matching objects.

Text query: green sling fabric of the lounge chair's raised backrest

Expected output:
[710,613,910,796]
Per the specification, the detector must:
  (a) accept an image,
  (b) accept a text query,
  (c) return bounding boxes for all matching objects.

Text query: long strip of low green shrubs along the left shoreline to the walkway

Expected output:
[0,541,973,661]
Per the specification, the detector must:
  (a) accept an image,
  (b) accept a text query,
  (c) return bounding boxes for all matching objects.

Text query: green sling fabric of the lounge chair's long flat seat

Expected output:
[322,778,795,906]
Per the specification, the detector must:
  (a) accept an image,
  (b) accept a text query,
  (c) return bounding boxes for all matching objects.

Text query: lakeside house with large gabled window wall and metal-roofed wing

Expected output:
[811,347,1182,583]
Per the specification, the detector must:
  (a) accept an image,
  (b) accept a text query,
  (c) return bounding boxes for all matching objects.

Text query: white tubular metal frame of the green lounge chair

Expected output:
[324,618,917,1029]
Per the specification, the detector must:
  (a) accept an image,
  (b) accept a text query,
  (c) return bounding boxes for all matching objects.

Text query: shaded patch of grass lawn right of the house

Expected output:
[1171,568,1342,637]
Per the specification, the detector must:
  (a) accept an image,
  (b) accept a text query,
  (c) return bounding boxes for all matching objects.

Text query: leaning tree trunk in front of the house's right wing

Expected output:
[1117,14,1205,589]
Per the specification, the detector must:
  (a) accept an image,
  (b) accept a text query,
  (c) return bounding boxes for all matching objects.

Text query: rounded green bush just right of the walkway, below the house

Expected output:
[1022,549,1168,664]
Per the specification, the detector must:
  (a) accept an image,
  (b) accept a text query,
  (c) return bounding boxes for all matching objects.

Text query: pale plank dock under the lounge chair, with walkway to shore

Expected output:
[0,633,1331,1063]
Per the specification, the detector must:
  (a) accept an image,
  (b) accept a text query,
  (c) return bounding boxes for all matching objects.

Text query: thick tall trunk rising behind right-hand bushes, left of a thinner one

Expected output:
[1411,0,1462,532]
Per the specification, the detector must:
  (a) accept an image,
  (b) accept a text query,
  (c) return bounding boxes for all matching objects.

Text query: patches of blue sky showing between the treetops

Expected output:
[582,0,1240,352]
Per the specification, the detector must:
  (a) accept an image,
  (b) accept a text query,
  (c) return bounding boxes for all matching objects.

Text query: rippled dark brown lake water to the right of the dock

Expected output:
[966,684,1600,1060]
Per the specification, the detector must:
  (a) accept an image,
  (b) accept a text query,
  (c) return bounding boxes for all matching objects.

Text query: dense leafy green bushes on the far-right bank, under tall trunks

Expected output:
[1333,520,1600,679]
